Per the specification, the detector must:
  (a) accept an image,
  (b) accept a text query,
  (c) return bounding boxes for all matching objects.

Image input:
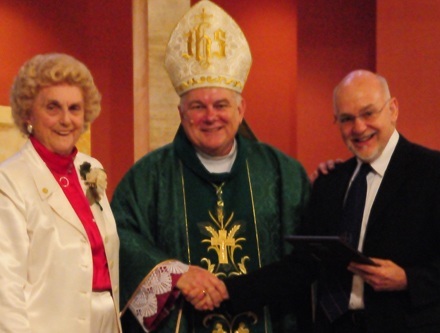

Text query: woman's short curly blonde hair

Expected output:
[10,53,101,135]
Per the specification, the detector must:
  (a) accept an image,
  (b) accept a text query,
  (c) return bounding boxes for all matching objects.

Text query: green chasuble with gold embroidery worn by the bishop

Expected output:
[112,128,310,333]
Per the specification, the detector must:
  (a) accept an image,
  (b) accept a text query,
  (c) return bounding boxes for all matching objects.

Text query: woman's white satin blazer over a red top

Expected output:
[0,141,119,333]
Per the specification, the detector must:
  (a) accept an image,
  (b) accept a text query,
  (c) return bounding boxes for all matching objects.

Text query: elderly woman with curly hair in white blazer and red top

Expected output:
[0,54,120,333]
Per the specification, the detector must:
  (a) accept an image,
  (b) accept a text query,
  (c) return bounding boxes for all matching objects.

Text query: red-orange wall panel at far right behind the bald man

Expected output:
[377,0,440,149]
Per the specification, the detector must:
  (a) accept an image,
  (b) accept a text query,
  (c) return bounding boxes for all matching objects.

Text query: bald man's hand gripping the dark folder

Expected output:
[348,258,408,291]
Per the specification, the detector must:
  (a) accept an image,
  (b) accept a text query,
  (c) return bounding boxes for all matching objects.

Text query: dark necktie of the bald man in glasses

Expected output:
[320,163,372,321]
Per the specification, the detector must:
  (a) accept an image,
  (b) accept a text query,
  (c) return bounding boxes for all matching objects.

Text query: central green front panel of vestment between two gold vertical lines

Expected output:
[175,129,271,333]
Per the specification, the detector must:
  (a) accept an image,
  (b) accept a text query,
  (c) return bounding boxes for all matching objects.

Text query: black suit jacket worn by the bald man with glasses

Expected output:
[226,136,440,333]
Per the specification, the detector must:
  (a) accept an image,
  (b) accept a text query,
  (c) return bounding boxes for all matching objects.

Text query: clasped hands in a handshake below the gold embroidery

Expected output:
[176,266,229,310]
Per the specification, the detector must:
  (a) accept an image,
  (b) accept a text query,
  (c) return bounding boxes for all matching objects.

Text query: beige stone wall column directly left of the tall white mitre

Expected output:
[133,0,190,160]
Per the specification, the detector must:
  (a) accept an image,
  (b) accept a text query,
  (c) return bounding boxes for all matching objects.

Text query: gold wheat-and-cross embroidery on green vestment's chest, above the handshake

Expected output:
[201,183,249,277]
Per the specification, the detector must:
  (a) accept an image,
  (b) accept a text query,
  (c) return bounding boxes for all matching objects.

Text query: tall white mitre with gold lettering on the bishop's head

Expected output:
[165,0,252,96]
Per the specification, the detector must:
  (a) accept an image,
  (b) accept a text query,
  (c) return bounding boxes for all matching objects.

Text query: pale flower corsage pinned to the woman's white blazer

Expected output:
[79,162,107,210]
